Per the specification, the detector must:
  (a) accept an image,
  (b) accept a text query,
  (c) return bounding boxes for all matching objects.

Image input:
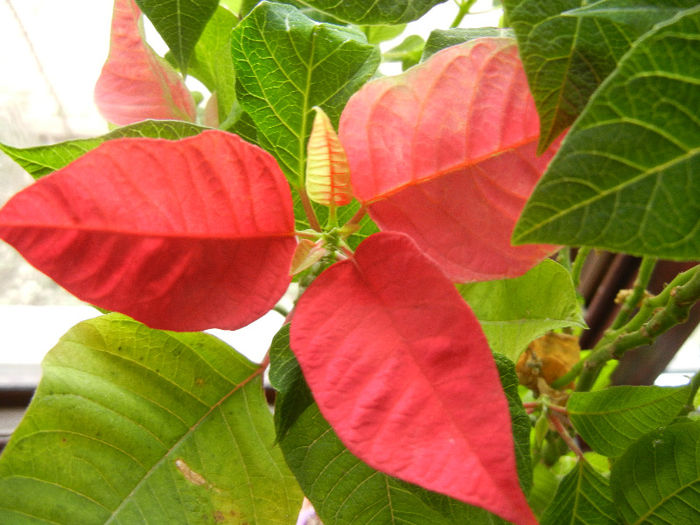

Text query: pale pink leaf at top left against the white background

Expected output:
[95,0,195,126]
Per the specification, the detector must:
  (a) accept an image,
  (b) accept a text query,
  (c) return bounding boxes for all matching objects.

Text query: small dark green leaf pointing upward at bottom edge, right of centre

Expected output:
[540,460,620,525]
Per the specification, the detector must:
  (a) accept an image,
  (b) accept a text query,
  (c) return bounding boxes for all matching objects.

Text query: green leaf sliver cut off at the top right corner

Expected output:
[563,0,697,35]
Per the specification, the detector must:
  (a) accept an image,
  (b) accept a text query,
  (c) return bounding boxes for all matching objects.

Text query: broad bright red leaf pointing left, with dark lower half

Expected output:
[0,130,296,331]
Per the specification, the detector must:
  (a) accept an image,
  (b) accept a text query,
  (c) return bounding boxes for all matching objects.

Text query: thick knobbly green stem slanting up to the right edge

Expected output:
[576,265,700,391]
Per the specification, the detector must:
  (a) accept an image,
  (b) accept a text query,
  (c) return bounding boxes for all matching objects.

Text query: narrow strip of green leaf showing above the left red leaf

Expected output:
[0,120,206,179]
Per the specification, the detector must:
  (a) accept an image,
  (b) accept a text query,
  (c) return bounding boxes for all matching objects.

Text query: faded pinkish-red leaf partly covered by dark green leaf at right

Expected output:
[340,38,558,282]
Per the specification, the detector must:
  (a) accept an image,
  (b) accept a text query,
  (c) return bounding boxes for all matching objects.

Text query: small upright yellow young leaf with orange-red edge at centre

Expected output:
[306,107,352,206]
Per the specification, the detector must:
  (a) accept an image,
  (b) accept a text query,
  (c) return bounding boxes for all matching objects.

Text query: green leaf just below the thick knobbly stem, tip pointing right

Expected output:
[567,386,690,458]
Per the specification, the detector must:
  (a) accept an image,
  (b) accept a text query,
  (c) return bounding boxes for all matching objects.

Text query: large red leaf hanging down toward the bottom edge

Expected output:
[291,233,536,524]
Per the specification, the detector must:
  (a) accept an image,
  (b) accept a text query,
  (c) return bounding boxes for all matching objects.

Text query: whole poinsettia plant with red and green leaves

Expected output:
[0,0,700,525]
